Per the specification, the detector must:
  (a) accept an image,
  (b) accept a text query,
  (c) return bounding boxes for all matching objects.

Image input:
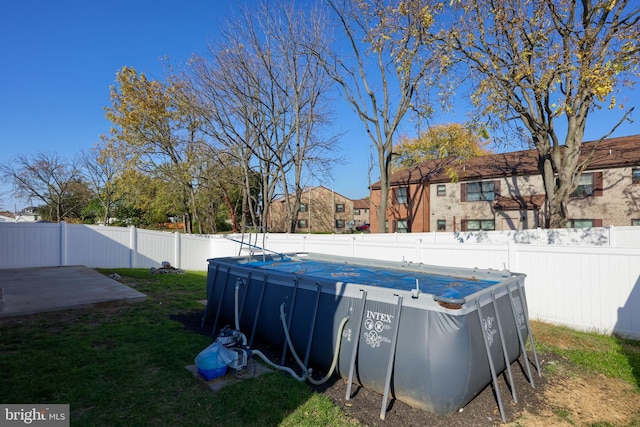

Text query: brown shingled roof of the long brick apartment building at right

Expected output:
[371,135,640,190]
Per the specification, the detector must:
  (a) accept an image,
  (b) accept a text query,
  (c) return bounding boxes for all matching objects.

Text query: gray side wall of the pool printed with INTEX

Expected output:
[205,254,527,415]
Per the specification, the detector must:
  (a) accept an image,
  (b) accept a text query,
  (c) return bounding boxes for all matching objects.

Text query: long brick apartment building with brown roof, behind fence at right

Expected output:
[370,135,640,233]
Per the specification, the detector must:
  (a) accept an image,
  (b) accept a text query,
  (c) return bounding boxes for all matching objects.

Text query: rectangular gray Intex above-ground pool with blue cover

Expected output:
[203,254,539,419]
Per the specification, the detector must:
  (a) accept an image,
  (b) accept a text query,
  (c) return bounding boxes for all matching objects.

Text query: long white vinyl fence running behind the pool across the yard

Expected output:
[0,223,640,338]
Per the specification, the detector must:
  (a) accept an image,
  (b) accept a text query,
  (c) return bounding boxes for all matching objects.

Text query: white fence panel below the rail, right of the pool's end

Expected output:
[517,245,640,337]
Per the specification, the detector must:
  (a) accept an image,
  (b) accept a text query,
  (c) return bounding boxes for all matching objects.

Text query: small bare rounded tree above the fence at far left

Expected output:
[0,152,87,222]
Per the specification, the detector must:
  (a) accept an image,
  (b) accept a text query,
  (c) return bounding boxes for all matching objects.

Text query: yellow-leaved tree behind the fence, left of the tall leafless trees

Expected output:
[106,67,205,233]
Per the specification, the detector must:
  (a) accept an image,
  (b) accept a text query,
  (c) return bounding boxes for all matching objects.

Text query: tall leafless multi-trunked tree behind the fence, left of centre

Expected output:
[191,2,334,231]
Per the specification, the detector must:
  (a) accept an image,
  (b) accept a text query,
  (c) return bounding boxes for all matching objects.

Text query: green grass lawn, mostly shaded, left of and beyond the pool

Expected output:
[0,270,640,426]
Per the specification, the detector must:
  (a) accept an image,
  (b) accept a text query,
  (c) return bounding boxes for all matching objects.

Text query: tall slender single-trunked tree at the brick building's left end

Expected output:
[316,0,441,232]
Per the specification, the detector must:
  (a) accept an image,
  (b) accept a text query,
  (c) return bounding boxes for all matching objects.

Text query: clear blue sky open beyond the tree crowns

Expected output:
[0,0,640,210]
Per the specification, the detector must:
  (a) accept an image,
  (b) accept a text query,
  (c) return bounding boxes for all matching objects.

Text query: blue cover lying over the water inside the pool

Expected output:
[245,259,499,299]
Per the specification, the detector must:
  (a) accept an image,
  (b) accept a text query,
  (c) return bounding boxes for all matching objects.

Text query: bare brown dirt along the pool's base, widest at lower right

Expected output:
[173,312,640,427]
